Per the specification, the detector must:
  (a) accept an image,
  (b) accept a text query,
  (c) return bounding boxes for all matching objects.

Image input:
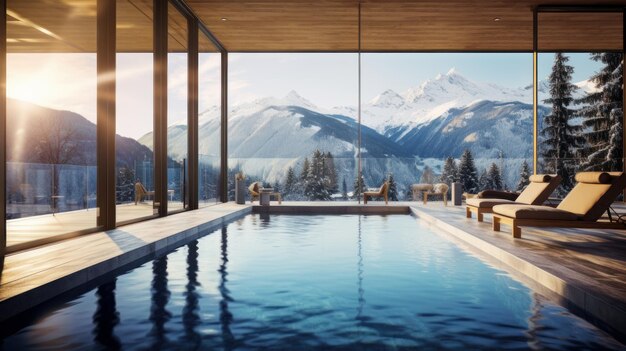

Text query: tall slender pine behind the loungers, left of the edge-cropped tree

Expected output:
[541,52,584,195]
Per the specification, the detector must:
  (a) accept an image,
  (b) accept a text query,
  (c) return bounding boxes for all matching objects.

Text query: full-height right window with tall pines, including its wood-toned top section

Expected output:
[537,11,624,197]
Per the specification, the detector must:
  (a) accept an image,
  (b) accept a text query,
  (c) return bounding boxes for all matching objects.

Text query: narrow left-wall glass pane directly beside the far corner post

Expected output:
[198,31,222,207]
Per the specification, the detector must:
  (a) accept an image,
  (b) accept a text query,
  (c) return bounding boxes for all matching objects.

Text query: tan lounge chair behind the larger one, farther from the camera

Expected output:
[465,174,561,222]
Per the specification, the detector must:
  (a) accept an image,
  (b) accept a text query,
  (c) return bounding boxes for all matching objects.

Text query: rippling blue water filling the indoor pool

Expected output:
[0,215,624,350]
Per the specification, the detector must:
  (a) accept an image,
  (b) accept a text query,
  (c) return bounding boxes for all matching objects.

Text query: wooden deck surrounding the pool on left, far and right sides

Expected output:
[0,201,626,341]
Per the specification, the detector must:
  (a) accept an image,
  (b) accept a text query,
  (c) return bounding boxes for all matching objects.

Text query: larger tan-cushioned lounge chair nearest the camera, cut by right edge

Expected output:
[493,172,626,238]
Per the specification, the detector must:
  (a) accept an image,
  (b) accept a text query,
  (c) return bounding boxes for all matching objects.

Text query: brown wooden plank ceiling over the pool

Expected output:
[7,0,626,52]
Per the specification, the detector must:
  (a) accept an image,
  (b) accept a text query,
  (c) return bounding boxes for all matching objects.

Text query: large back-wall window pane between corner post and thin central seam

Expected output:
[228,54,358,201]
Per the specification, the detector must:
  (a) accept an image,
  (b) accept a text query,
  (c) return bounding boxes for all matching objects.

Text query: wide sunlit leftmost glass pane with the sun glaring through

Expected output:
[3,0,98,246]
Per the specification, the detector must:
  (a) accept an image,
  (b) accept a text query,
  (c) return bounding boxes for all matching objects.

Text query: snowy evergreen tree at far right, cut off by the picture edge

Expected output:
[578,52,624,171]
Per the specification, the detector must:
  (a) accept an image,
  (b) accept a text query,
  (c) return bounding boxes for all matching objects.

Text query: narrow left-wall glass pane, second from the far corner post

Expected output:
[167,4,188,212]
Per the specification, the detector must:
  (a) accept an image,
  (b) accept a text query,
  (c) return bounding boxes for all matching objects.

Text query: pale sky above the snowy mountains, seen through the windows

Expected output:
[7,53,600,138]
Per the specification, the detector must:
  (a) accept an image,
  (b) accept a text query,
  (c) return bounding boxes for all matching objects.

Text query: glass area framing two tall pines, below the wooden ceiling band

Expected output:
[538,52,624,197]
